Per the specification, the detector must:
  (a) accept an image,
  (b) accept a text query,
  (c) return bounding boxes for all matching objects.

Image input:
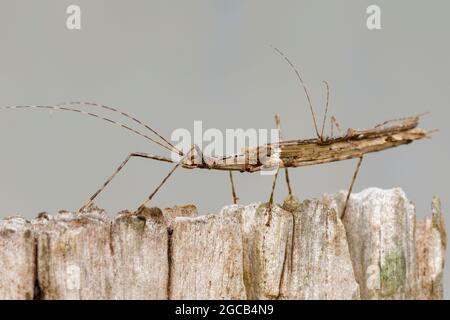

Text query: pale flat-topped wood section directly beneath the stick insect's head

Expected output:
[169,209,246,299]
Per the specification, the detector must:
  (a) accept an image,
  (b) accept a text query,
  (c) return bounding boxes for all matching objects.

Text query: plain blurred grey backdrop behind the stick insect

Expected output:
[0,0,450,297]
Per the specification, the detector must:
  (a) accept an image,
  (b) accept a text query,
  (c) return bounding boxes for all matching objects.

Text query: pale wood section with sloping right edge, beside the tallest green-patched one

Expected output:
[285,199,359,299]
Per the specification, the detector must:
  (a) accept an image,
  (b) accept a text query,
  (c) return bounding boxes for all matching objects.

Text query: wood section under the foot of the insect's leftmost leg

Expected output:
[34,208,114,300]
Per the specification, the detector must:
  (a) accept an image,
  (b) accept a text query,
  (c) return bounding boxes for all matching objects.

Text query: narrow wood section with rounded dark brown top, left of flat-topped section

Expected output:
[111,208,169,299]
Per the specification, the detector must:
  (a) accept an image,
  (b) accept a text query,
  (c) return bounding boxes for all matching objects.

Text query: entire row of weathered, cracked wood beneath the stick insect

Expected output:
[0,188,446,299]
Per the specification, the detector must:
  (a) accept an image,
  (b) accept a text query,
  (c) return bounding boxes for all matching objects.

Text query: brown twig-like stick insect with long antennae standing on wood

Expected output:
[0,48,431,224]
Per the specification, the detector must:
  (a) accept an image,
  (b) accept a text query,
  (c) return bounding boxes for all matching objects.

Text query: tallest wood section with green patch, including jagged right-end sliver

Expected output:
[324,188,446,299]
